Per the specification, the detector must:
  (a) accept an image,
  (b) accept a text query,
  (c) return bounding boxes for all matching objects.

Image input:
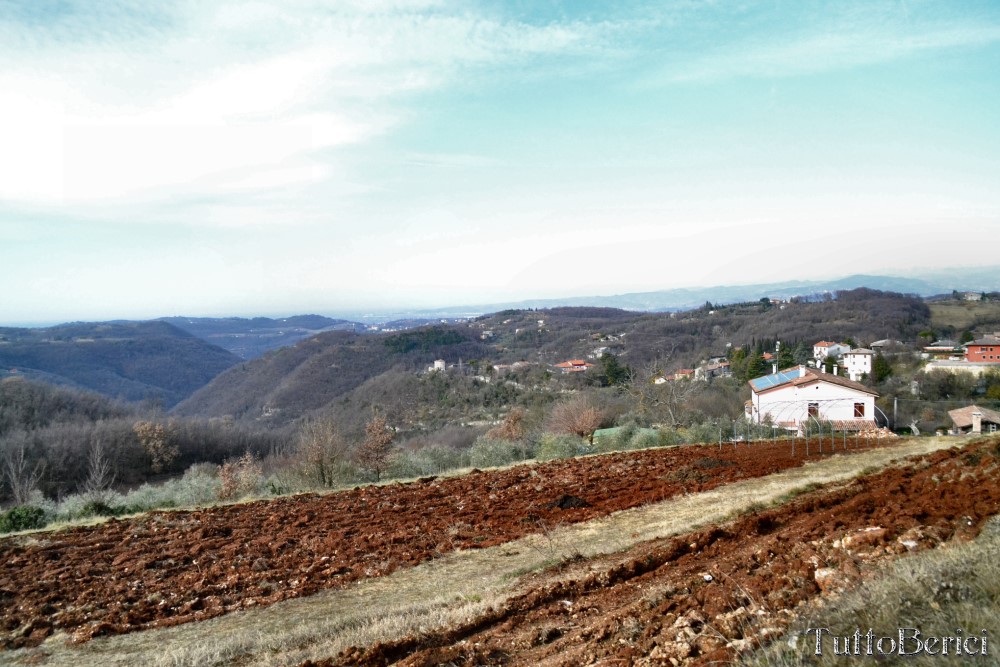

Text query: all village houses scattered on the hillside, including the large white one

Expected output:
[418,300,1000,435]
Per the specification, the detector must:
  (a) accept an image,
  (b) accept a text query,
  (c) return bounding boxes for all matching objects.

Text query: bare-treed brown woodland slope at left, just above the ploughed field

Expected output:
[0,377,288,504]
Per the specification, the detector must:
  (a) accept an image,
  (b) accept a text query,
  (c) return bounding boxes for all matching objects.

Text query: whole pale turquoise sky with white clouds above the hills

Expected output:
[0,0,1000,324]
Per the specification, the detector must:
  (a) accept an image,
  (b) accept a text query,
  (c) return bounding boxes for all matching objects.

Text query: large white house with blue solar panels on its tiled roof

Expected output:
[747,366,878,432]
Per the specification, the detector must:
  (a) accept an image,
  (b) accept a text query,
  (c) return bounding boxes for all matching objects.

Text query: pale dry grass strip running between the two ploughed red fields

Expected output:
[7,438,956,667]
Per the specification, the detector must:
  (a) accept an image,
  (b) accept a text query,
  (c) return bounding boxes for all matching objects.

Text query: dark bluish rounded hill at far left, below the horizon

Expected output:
[0,322,239,407]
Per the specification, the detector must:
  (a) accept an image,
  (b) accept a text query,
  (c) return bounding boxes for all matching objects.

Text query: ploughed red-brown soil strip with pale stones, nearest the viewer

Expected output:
[322,439,1000,667]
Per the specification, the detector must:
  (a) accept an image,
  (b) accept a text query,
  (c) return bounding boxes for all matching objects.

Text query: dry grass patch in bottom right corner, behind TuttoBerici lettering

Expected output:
[742,519,1000,667]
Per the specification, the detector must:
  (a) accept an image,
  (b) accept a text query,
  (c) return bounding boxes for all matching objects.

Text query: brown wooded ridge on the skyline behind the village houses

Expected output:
[474,288,930,371]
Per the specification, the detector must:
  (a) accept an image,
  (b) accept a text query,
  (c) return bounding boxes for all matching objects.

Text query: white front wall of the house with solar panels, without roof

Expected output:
[750,380,875,425]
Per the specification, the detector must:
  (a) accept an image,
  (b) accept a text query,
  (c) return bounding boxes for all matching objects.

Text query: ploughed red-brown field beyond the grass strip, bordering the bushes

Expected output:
[0,441,892,648]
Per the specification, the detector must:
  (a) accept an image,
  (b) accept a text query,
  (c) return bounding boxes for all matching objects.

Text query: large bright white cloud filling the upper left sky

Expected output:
[0,1,612,224]
